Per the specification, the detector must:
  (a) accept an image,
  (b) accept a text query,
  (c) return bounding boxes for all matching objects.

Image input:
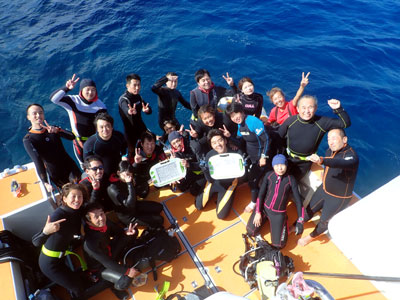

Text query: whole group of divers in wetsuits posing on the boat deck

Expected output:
[23,69,358,299]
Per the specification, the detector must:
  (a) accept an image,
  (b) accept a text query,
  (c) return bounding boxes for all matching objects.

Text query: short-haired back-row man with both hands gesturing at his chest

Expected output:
[118,73,152,154]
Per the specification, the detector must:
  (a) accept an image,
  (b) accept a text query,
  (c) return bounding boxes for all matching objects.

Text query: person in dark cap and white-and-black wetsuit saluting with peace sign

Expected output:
[50,74,107,165]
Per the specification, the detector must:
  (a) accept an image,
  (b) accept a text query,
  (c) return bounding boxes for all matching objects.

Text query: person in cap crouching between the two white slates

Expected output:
[168,128,205,196]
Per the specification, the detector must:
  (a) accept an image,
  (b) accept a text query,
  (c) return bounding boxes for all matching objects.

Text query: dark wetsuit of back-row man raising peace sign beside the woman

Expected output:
[190,86,237,118]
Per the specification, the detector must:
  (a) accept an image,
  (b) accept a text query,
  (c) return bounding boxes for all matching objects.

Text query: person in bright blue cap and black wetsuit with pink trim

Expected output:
[246,154,304,248]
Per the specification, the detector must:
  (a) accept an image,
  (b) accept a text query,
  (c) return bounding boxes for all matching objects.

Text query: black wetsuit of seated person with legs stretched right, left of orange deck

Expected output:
[107,180,164,227]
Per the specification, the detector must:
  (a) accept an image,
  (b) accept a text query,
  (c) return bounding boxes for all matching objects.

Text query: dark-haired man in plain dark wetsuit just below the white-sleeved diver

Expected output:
[83,113,127,179]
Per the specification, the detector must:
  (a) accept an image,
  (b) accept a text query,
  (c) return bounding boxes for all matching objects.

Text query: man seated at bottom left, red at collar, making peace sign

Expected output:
[83,203,139,299]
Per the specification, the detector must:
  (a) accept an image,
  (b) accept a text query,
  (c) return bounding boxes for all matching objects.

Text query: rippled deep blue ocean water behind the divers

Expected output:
[0,0,400,196]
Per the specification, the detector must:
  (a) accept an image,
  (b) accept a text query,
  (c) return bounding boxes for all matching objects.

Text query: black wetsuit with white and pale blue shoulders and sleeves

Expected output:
[50,87,107,163]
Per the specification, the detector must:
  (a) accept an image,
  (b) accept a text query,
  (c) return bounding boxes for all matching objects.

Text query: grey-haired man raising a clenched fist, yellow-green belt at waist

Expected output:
[278,95,351,182]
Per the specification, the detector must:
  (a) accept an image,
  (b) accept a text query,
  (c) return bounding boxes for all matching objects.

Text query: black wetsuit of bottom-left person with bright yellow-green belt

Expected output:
[32,206,85,296]
